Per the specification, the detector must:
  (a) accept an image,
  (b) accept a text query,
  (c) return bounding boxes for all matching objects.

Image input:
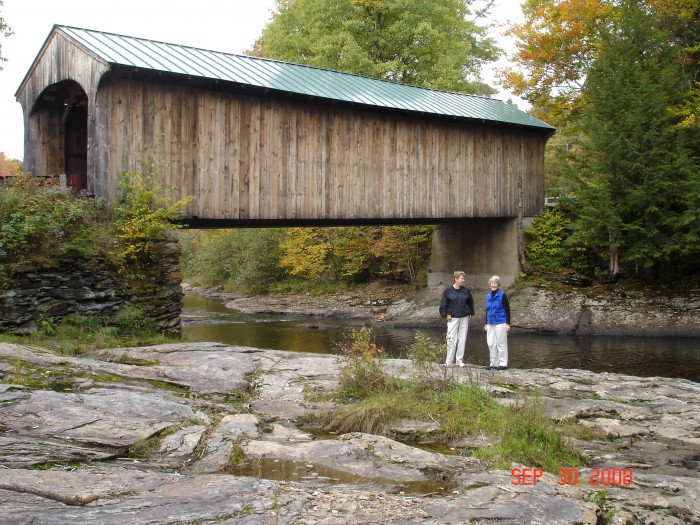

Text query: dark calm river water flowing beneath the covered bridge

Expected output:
[182,295,700,382]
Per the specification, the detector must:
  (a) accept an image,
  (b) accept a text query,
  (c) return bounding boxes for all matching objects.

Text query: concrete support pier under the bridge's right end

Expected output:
[428,219,520,295]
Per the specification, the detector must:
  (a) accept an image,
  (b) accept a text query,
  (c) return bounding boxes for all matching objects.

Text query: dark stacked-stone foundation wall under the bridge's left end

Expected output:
[0,240,183,335]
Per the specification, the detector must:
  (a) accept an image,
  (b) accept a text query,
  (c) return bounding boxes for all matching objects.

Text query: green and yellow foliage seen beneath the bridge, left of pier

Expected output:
[182,226,432,292]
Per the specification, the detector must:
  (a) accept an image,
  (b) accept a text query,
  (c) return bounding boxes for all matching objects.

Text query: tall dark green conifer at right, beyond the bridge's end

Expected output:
[575,5,700,277]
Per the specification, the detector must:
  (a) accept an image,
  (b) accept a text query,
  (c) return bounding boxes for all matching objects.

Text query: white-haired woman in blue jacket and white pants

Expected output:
[484,275,510,370]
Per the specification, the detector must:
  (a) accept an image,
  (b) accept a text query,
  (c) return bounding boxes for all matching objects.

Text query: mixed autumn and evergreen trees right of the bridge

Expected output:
[504,0,700,278]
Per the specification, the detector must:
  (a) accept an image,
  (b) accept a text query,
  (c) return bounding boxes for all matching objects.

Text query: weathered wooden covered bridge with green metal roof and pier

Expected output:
[16,26,553,290]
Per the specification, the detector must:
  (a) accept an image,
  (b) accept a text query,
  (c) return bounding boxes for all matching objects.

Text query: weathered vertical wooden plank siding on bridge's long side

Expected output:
[92,79,546,220]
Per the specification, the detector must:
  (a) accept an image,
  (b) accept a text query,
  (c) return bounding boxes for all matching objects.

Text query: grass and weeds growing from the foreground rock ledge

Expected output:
[320,327,584,472]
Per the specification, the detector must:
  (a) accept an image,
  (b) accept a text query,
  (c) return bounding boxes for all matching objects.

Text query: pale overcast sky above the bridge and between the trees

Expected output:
[0,0,524,160]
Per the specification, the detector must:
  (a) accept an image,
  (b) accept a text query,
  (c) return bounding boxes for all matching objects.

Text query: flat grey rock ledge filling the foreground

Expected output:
[0,343,700,525]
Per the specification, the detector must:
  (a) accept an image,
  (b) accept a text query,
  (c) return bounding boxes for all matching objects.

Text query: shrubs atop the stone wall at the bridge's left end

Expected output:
[0,139,190,335]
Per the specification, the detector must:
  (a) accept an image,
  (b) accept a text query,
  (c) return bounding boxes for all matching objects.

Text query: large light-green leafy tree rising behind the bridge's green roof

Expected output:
[252,0,500,94]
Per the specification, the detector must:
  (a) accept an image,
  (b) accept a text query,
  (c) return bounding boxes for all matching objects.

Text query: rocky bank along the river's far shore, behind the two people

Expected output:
[184,285,700,337]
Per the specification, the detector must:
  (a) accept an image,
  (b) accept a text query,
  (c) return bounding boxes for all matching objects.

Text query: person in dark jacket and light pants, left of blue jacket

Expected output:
[440,272,474,366]
